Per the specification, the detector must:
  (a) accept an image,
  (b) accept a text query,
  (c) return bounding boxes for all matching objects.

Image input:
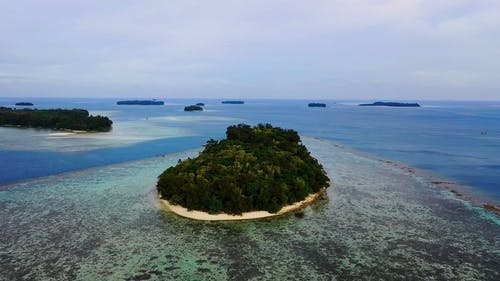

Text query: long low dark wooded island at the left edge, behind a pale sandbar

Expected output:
[0,107,113,132]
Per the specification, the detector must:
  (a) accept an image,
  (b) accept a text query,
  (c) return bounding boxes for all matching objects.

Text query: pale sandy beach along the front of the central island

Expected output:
[159,187,326,221]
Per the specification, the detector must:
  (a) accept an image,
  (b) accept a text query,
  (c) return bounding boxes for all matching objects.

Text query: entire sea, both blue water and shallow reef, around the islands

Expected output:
[0,98,500,280]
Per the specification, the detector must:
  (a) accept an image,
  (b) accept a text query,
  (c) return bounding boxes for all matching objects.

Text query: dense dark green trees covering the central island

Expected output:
[157,124,329,214]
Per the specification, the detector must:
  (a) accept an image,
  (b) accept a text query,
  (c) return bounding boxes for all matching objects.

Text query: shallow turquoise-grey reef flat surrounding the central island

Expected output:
[0,138,500,280]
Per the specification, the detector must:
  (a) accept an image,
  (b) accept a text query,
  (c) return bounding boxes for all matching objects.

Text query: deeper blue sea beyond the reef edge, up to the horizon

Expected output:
[0,98,500,203]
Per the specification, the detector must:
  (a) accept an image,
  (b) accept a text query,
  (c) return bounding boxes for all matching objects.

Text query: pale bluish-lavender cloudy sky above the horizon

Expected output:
[0,0,500,100]
